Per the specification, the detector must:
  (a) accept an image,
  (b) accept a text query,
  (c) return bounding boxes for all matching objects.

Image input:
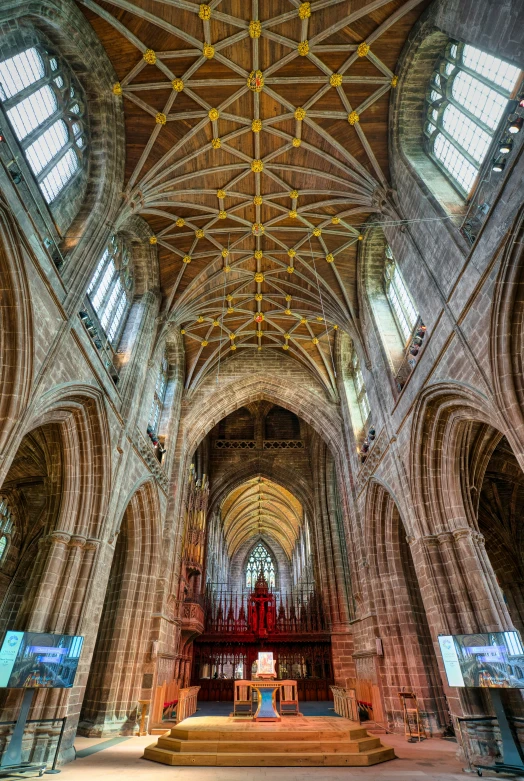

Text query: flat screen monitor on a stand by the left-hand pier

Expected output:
[0,630,84,689]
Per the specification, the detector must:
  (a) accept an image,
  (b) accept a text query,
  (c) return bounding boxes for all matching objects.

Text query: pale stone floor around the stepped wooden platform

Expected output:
[55,703,482,781]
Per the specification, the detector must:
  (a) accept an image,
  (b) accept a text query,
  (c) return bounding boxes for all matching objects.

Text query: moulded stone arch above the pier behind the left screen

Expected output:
[12,383,111,539]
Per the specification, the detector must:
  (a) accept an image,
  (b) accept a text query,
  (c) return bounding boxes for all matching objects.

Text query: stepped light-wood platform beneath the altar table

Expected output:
[144,716,395,767]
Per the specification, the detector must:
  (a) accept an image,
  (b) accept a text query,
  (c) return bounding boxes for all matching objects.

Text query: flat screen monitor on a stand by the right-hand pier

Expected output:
[438,632,524,689]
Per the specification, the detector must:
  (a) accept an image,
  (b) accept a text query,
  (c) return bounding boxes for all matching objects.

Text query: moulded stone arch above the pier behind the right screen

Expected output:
[410,382,522,537]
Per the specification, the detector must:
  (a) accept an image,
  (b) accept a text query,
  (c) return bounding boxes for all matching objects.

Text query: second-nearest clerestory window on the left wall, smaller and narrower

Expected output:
[87,236,133,347]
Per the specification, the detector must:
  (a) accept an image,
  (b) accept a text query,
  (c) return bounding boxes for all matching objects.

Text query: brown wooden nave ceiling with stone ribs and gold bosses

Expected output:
[78,0,428,389]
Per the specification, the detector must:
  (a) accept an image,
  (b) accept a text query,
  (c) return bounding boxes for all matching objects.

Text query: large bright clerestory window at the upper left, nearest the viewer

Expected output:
[0,46,86,203]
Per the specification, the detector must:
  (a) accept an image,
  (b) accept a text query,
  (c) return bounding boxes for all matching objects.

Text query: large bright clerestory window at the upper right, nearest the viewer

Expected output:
[425,43,521,196]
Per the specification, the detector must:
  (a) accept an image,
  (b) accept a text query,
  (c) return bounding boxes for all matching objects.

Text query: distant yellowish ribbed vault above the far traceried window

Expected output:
[221,477,303,558]
